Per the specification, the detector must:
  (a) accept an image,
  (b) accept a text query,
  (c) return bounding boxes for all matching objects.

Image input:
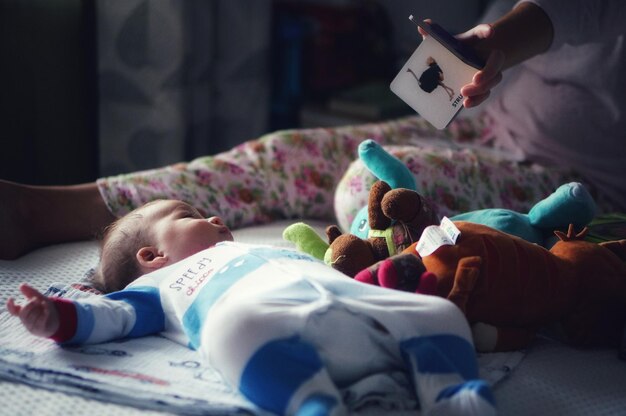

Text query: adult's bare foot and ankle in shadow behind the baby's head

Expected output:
[0,180,115,260]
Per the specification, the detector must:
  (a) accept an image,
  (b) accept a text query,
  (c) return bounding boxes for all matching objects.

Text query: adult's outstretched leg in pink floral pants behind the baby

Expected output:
[98,117,444,228]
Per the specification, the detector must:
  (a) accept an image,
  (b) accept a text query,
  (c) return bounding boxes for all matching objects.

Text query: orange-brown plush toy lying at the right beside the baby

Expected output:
[355,221,626,351]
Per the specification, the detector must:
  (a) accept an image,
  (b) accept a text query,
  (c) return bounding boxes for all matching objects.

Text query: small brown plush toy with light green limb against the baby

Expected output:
[283,181,439,277]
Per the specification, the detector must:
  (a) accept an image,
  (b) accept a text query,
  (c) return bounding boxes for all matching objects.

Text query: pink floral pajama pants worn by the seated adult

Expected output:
[97,116,579,230]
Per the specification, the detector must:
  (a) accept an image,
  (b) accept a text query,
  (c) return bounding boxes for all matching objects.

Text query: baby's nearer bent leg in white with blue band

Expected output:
[206,300,346,415]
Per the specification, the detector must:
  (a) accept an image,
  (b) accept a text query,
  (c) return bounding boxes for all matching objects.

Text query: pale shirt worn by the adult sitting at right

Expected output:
[487,0,626,210]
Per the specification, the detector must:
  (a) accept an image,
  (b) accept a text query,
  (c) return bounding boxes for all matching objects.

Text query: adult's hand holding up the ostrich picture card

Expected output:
[418,19,505,108]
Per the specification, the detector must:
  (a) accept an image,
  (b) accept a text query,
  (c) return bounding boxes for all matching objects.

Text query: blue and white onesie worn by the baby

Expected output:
[48,242,495,415]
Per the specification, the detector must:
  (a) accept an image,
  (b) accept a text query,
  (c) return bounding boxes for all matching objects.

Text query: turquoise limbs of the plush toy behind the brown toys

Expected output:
[350,140,597,248]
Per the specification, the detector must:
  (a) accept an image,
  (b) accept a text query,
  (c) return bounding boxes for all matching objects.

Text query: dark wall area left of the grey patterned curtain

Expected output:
[0,0,97,184]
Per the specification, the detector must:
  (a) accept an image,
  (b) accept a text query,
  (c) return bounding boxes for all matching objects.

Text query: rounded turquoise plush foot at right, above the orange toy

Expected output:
[528,182,597,229]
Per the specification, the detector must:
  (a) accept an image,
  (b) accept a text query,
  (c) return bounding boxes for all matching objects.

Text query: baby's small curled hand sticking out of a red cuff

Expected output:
[7,283,59,338]
